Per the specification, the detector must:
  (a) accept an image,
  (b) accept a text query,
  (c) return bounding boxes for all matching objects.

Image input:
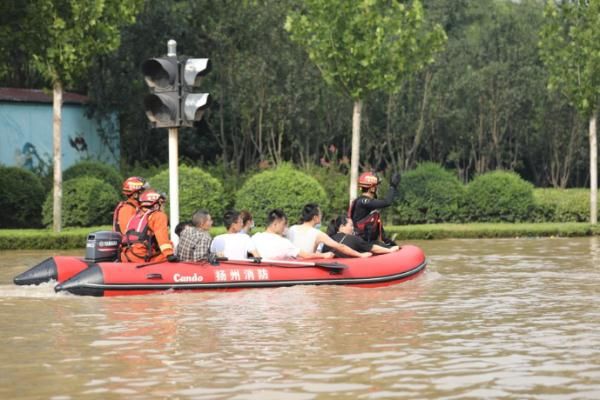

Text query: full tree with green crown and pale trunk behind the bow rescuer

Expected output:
[285,0,446,200]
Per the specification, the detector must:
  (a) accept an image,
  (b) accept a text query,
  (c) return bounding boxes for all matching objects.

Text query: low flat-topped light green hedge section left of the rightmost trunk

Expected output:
[532,189,590,222]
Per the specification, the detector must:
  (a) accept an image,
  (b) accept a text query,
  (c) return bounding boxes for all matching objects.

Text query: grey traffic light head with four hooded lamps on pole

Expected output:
[142,56,211,128]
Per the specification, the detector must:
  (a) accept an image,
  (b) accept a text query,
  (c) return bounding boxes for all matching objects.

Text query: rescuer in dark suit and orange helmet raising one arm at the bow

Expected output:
[348,172,400,247]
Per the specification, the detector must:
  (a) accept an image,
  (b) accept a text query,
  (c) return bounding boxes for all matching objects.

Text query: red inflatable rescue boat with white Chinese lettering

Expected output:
[14,233,427,296]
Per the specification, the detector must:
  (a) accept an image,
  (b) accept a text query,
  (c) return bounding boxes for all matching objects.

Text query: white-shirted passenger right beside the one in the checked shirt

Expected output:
[210,210,258,260]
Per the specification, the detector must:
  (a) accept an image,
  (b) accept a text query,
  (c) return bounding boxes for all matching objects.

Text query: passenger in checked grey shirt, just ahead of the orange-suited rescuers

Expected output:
[177,210,212,261]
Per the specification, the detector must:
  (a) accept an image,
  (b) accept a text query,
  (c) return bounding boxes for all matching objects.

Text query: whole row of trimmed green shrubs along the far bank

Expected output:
[0,161,589,228]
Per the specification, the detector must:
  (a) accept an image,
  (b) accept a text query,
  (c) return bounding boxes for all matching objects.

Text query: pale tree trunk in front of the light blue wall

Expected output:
[52,81,63,232]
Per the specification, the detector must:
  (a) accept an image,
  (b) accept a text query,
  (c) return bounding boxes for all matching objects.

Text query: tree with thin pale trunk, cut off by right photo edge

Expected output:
[540,0,600,224]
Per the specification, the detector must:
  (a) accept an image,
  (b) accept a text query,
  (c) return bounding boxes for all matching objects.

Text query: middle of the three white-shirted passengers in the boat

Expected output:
[252,209,333,259]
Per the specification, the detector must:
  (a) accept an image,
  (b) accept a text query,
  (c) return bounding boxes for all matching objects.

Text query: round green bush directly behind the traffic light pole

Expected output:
[149,165,225,223]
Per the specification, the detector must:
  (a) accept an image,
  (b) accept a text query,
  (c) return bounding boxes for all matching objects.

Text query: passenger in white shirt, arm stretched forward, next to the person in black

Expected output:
[287,203,372,257]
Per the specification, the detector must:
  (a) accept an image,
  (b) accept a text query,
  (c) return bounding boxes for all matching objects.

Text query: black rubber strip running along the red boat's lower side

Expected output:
[65,261,427,291]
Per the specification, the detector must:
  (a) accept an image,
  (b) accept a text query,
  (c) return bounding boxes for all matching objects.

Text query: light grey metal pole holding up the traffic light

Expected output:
[167,39,179,246]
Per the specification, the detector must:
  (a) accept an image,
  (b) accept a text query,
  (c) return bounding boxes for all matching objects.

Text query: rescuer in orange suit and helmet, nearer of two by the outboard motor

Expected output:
[121,189,178,262]
